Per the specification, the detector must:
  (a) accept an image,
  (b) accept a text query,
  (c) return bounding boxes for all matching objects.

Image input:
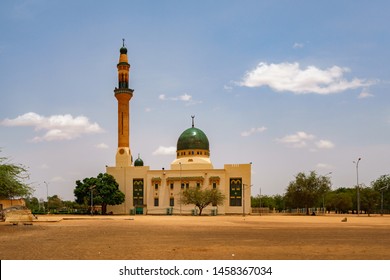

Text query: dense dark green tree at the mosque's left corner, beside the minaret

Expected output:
[74,173,125,215]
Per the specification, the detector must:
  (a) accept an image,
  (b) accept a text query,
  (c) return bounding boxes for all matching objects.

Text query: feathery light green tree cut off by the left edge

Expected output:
[0,152,33,199]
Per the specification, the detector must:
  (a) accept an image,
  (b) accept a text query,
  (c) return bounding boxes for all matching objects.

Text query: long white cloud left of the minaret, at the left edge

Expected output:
[0,112,103,142]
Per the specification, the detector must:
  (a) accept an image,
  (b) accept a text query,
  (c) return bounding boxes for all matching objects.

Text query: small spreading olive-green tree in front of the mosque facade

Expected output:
[180,187,225,216]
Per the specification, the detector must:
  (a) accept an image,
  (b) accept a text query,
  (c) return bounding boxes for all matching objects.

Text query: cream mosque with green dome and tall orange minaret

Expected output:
[106,44,251,215]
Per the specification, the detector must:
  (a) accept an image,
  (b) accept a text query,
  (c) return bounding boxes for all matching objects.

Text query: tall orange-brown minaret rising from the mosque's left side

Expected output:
[114,39,134,167]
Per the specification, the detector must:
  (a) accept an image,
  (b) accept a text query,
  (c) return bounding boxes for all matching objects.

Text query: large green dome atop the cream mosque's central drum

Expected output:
[177,127,210,151]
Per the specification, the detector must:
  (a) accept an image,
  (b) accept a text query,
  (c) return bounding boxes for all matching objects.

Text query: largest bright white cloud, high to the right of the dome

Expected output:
[237,62,374,94]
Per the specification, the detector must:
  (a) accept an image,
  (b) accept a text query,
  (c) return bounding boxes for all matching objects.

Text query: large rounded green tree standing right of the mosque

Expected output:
[285,171,331,215]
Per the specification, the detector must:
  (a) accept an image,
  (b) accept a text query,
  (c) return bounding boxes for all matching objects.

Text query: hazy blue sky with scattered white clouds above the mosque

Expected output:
[0,0,390,200]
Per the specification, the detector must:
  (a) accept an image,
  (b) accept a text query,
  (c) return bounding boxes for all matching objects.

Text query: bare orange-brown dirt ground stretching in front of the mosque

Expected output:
[0,215,390,260]
